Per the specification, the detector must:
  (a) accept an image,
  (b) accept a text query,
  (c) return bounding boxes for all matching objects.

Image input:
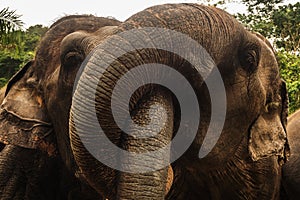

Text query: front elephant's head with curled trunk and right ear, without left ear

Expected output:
[60,4,288,199]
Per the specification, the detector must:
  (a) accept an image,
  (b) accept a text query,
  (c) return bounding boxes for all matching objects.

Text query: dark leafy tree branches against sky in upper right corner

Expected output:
[236,0,300,53]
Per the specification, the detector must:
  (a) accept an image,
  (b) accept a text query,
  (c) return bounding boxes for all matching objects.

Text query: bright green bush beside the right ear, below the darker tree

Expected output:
[277,52,300,113]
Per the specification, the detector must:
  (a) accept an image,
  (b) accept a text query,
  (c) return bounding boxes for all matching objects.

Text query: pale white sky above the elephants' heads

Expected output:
[0,0,299,28]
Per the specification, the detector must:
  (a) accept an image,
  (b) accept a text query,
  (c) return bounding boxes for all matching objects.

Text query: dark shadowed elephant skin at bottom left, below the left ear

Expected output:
[0,145,99,200]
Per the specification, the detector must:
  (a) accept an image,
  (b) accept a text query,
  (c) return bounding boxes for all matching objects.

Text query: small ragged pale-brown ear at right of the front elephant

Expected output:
[249,81,290,162]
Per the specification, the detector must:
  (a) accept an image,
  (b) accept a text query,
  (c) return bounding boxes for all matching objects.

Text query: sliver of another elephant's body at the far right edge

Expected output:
[282,110,300,200]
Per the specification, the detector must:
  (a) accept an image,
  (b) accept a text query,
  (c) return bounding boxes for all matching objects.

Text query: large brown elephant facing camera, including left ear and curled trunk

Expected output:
[0,3,288,199]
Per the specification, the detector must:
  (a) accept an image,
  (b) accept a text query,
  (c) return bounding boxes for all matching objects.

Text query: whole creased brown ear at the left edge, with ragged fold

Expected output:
[0,61,56,155]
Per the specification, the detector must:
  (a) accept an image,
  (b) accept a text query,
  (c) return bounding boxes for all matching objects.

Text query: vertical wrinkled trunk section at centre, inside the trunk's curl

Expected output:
[117,92,174,199]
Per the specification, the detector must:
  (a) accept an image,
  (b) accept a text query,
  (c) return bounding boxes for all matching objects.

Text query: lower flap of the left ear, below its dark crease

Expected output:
[0,107,56,156]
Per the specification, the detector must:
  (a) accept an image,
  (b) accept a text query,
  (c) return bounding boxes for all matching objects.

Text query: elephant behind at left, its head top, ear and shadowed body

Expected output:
[0,15,119,200]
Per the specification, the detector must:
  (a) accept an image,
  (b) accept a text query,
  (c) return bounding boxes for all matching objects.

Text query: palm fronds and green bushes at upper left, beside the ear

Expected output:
[0,8,48,87]
